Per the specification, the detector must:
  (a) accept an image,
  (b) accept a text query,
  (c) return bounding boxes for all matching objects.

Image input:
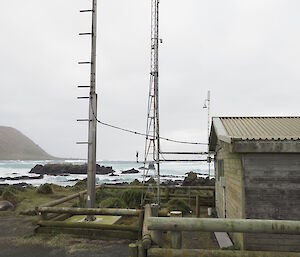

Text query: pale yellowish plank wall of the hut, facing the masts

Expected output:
[215,141,244,249]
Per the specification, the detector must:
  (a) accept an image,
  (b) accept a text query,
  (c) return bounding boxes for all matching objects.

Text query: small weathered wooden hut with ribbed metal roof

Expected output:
[209,117,300,251]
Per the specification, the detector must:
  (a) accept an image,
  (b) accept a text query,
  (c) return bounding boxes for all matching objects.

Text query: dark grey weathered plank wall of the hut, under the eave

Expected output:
[243,153,300,251]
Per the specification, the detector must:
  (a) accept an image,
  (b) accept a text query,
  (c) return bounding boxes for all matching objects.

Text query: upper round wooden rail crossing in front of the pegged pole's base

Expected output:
[37,207,141,216]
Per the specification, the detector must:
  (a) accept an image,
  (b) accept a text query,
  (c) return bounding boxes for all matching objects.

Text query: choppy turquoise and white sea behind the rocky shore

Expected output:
[0,160,213,186]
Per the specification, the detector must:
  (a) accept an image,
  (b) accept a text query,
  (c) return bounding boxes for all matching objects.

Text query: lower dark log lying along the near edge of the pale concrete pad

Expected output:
[38,221,139,232]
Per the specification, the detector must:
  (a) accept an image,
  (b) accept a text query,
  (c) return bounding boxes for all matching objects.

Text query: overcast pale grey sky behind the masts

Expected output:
[0,0,300,160]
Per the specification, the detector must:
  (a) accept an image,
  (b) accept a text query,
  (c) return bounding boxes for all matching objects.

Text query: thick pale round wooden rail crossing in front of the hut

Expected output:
[148,217,300,235]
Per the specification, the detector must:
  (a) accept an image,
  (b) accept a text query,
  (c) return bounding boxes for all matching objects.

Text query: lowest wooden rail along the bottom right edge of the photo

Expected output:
[148,248,300,257]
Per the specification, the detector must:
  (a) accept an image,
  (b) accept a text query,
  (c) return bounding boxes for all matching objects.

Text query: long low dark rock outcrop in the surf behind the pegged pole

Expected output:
[29,164,115,176]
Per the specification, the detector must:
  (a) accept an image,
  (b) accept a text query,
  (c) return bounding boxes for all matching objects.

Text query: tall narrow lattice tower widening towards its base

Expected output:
[142,0,160,204]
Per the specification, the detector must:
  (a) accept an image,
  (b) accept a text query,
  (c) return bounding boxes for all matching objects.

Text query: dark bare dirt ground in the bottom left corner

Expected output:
[0,215,130,257]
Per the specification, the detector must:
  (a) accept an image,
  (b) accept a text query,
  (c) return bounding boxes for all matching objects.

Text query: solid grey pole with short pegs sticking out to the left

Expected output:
[79,0,97,220]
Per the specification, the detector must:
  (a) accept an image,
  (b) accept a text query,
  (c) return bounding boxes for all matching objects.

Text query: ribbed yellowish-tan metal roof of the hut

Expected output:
[220,117,300,140]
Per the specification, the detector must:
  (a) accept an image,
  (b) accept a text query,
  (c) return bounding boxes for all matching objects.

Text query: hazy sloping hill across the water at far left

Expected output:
[0,126,56,160]
